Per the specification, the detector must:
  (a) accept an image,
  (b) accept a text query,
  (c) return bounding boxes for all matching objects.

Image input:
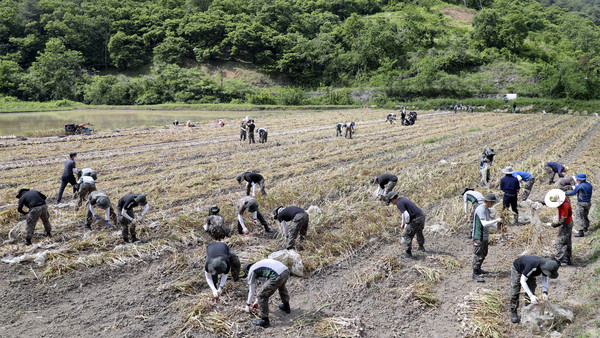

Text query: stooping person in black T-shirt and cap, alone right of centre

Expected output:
[386,191,425,258]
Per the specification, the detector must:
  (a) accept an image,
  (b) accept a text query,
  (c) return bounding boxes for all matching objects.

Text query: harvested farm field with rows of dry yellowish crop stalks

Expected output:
[0,110,600,337]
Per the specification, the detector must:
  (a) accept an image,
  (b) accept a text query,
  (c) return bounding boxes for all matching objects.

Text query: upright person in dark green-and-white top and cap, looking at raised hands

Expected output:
[471,194,502,283]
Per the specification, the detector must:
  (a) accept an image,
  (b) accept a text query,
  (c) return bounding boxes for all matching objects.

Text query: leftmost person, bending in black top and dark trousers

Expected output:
[16,188,52,245]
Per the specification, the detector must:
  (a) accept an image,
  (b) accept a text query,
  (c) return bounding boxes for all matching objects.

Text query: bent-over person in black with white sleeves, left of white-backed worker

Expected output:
[204,242,240,298]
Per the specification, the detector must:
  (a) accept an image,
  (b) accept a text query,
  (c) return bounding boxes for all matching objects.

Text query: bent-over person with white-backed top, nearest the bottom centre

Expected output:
[243,259,292,327]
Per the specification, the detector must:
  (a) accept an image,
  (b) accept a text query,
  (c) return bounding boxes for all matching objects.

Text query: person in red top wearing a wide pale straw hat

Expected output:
[545,189,573,265]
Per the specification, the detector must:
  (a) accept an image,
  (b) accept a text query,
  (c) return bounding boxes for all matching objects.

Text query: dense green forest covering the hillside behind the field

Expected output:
[0,0,600,105]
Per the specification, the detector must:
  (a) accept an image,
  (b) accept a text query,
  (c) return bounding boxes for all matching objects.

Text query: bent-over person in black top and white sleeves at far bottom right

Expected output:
[510,256,560,323]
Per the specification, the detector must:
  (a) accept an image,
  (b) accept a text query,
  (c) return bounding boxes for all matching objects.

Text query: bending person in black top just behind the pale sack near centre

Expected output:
[273,206,309,251]
